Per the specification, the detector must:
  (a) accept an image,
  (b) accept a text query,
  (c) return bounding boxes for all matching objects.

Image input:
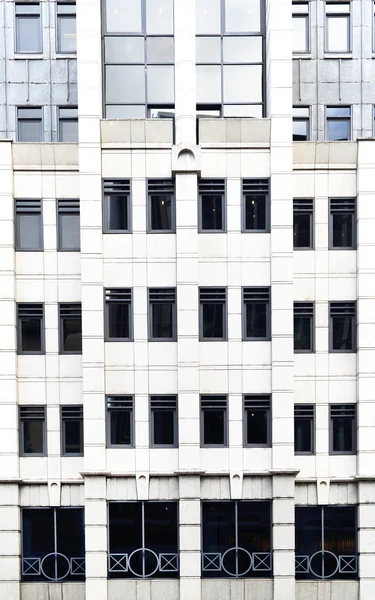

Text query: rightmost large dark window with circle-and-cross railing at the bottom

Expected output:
[295,506,358,579]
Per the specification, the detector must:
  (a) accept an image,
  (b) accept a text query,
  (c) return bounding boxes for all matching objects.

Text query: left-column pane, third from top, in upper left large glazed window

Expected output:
[105,65,146,104]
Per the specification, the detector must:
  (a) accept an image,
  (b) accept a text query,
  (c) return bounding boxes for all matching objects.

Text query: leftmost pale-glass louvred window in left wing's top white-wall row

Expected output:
[15,199,43,252]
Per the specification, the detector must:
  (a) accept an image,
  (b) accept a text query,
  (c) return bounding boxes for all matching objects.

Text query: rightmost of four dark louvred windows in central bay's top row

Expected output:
[242,179,270,233]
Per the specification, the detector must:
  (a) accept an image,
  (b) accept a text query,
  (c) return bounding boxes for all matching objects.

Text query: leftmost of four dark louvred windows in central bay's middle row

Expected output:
[105,288,133,342]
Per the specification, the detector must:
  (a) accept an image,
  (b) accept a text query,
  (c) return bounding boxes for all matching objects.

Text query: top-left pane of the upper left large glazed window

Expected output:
[106,0,142,33]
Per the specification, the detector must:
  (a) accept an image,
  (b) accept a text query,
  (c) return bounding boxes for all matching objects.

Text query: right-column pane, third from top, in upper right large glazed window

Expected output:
[223,65,262,104]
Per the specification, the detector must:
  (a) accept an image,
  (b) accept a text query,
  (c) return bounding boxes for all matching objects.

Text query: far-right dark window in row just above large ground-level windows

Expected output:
[329,404,357,454]
